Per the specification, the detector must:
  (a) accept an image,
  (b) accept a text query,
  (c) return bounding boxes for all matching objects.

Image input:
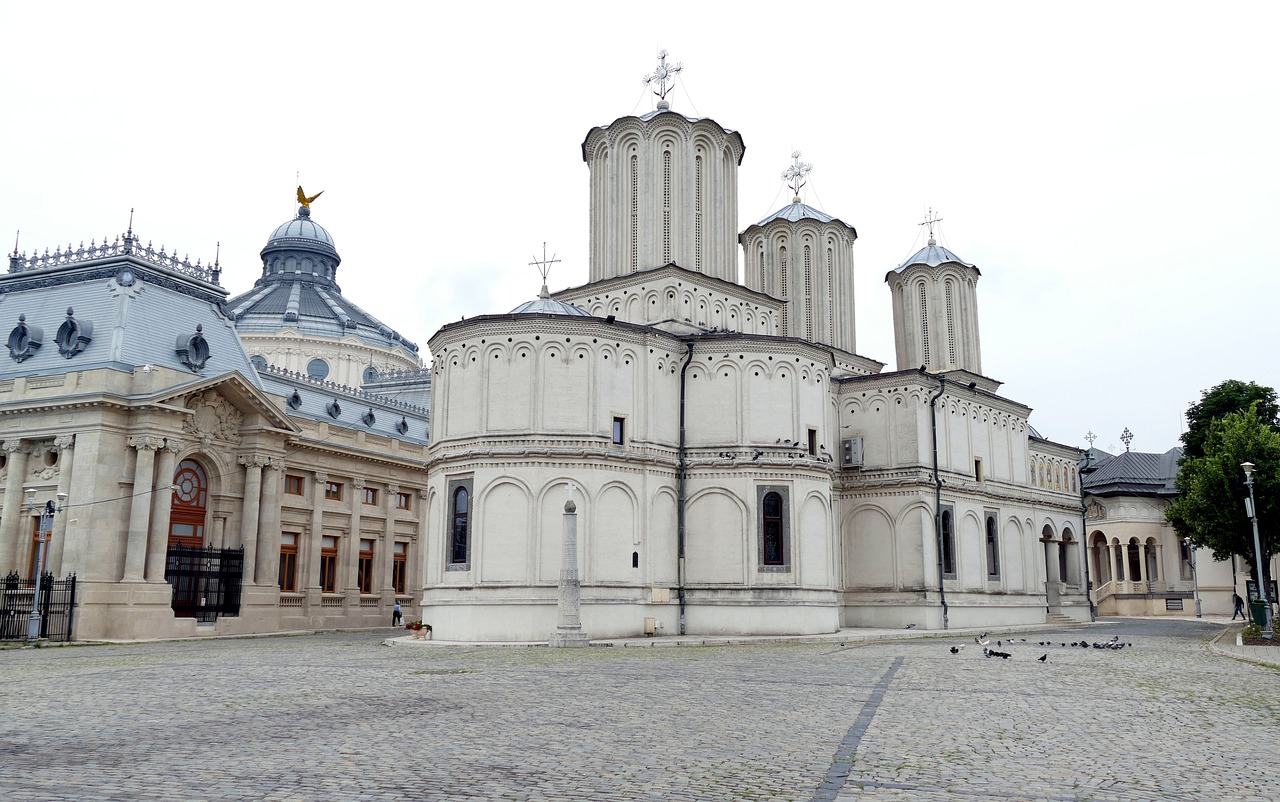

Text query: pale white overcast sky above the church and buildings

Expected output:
[0,1,1280,452]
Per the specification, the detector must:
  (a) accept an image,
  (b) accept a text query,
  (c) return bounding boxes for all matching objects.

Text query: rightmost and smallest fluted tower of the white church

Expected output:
[884,226,982,376]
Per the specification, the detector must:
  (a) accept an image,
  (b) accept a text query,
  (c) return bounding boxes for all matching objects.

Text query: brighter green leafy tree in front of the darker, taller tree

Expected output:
[1165,400,1280,590]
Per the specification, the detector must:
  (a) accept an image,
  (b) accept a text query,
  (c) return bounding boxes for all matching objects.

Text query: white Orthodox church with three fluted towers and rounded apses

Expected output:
[422,78,1089,641]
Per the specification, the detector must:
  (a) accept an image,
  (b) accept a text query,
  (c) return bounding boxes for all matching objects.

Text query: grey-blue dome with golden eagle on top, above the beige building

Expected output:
[227,205,426,388]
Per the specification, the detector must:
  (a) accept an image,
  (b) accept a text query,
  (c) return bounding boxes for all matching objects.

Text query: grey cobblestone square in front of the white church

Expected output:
[0,622,1280,802]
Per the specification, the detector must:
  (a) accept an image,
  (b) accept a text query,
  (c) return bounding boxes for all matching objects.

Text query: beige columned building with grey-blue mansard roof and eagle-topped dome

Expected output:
[0,207,429,640]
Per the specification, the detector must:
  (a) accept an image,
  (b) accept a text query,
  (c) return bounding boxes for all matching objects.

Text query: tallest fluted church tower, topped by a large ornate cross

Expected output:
[582,51,746,283]
